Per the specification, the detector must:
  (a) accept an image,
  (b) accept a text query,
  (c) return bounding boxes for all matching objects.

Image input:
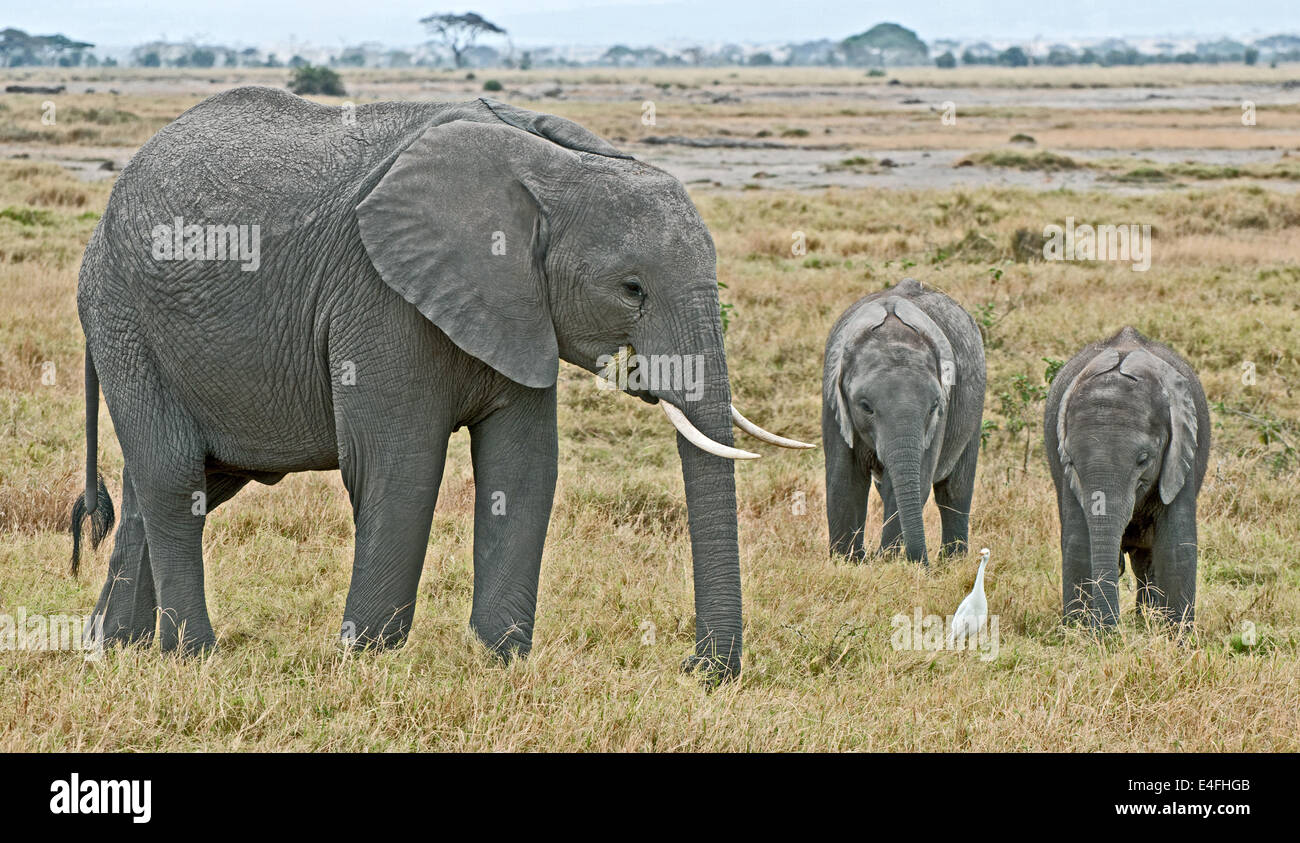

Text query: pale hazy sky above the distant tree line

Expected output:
[10,0,1300,47]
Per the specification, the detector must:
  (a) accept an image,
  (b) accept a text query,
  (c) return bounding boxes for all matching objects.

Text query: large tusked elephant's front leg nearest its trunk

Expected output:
[469,386,559,658]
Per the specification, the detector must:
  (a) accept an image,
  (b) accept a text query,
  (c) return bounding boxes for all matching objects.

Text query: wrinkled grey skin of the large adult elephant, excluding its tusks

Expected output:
[78,88,741,674]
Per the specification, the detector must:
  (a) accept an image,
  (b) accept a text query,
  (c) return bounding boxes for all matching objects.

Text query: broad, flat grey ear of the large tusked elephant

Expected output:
[356,120,577,388]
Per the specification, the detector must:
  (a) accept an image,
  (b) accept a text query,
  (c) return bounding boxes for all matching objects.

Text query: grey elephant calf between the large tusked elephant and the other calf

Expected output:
[822,278,984,562]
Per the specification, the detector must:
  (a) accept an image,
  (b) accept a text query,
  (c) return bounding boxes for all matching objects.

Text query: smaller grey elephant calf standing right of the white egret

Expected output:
[1043,328,1210,627]
